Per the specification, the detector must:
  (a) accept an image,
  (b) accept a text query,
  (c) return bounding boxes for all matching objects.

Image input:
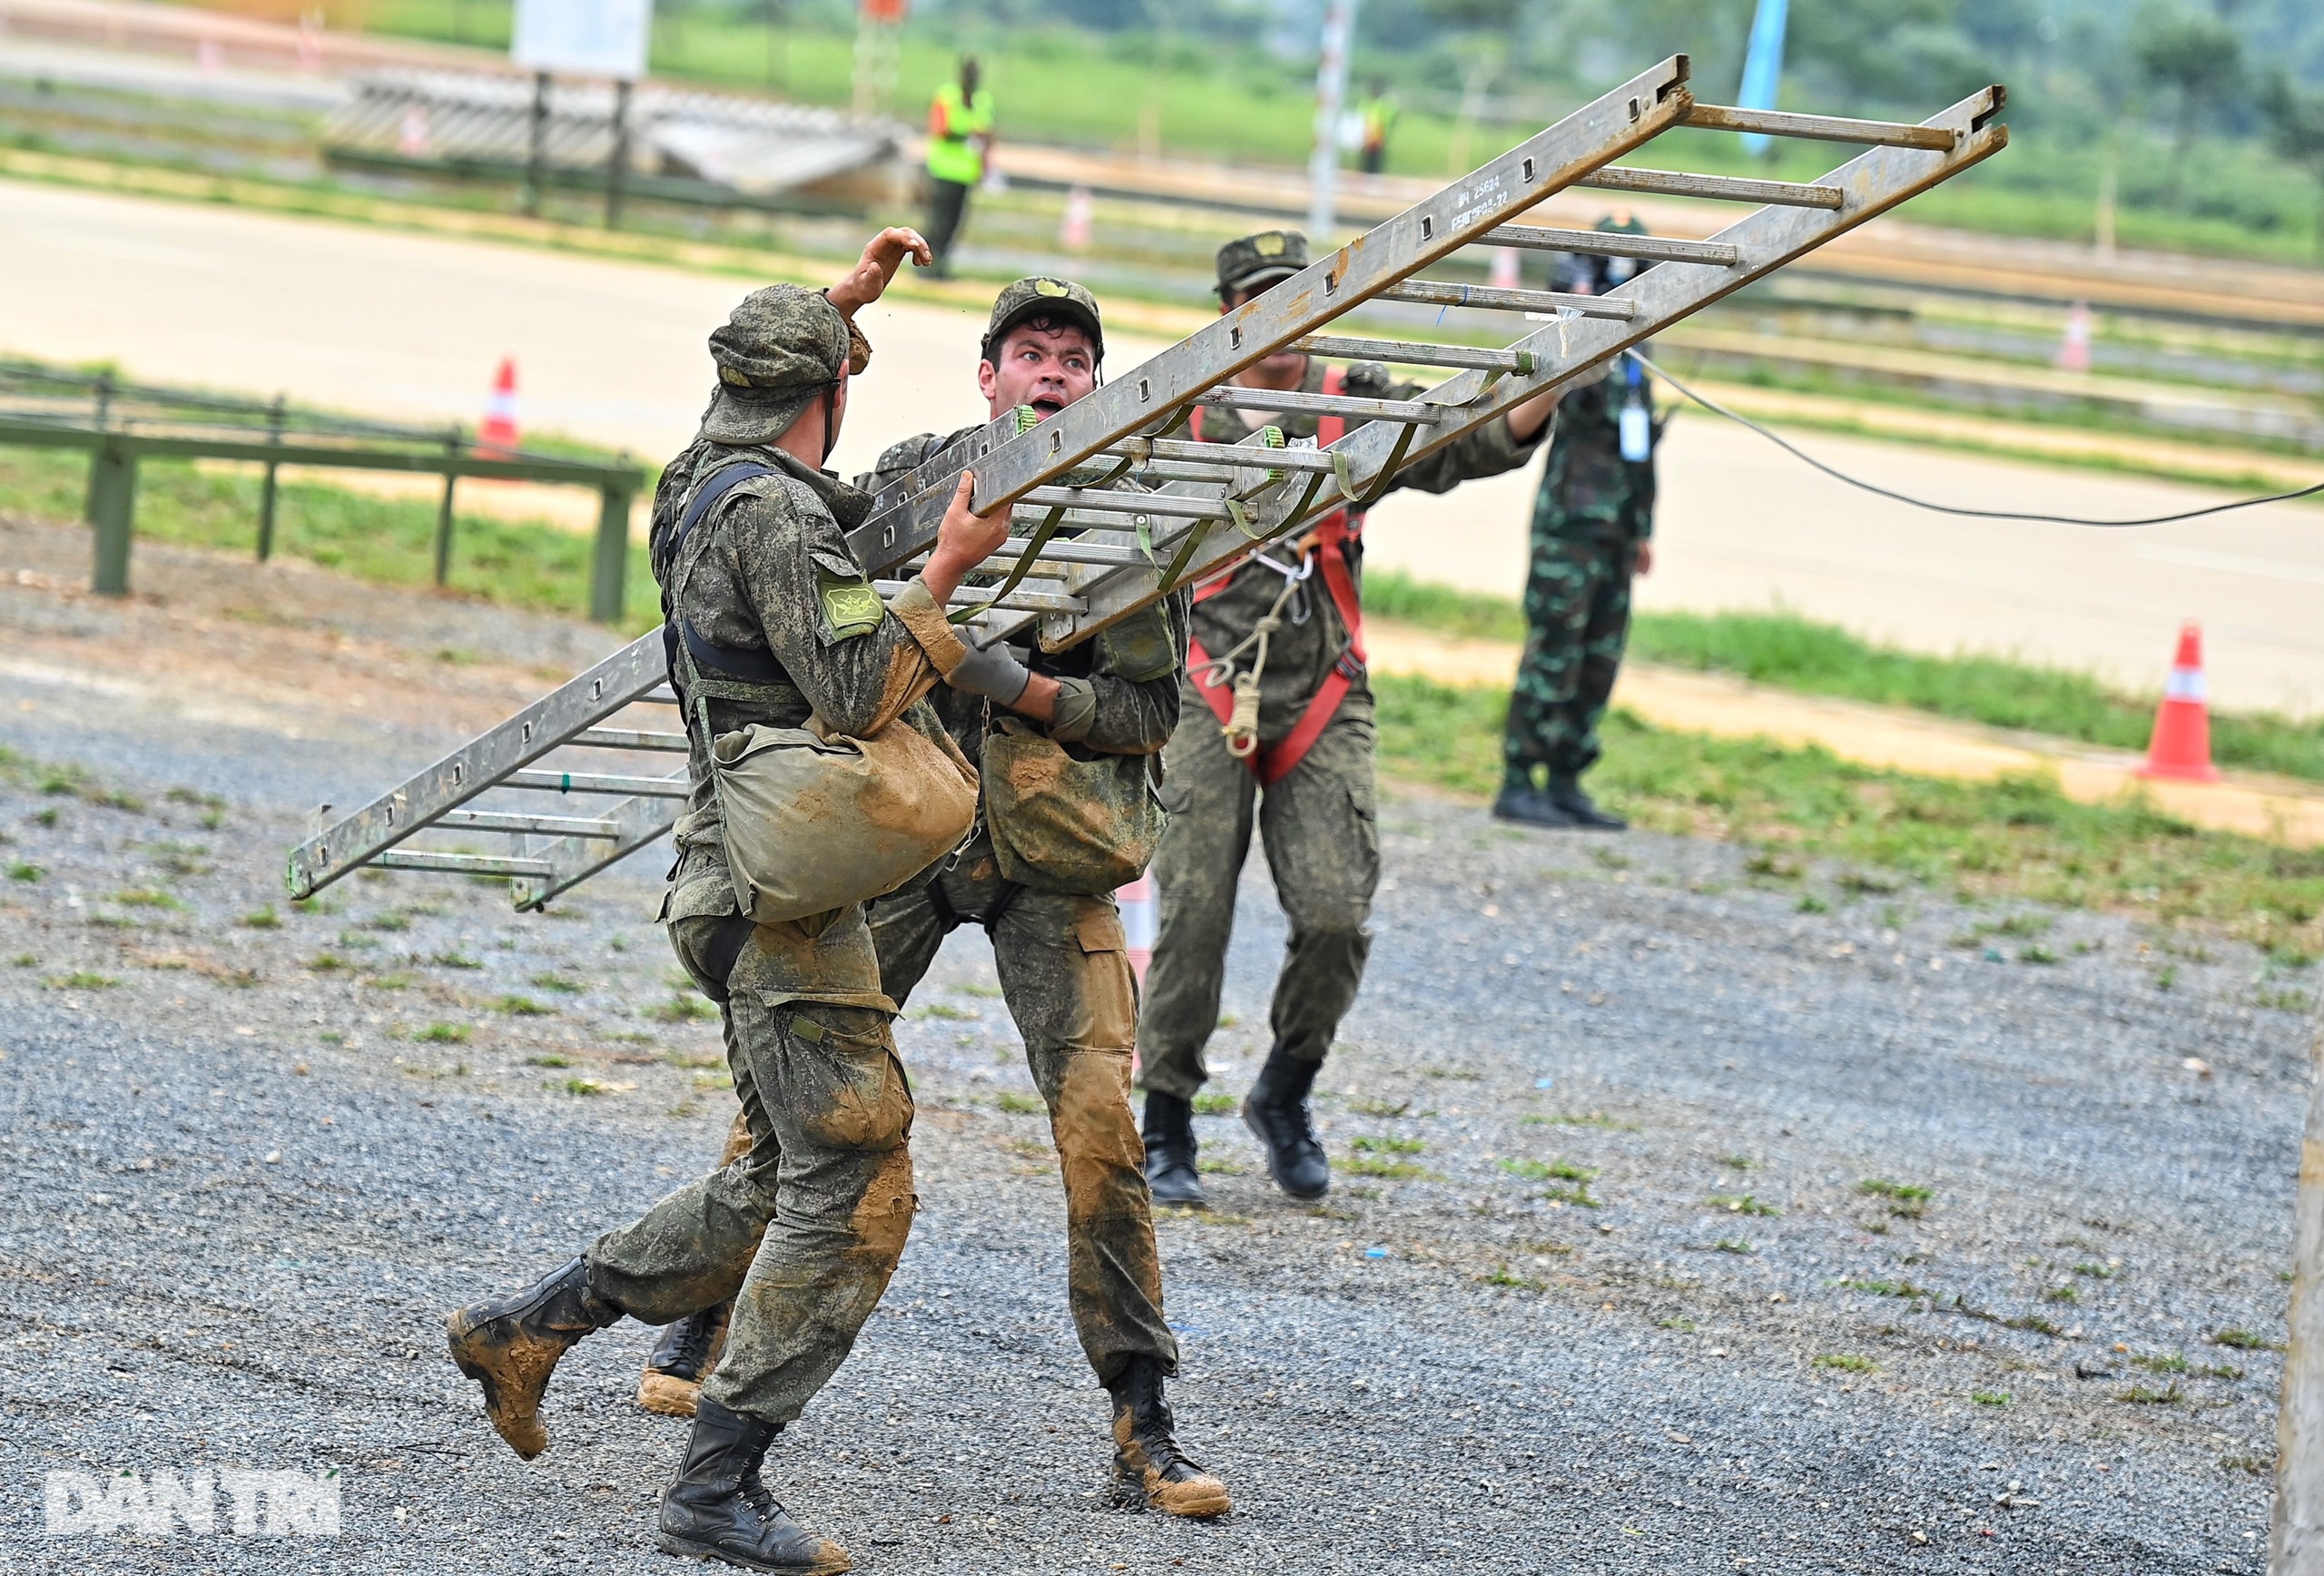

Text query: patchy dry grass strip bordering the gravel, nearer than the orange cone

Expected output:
[1374,675,2324,962]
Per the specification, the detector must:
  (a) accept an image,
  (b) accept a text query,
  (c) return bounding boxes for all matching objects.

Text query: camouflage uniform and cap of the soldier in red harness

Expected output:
[1138,232,1534,1099]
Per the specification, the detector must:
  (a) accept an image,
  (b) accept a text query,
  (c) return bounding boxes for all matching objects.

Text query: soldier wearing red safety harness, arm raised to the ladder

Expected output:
[1138,230,1555,1204]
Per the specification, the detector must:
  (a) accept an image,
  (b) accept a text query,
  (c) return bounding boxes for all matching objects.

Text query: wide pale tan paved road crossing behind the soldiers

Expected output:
[14,183,2324,714]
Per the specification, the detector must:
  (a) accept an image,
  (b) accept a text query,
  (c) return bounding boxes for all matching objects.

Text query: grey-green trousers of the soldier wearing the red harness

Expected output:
[1138,681,1381,1099]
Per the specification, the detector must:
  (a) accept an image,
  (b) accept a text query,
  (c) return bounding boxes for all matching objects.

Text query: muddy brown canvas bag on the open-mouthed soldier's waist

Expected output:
[983,718,1169,895]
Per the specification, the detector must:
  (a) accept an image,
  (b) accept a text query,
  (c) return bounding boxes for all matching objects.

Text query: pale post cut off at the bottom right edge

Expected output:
[2269,1000,2324,1576]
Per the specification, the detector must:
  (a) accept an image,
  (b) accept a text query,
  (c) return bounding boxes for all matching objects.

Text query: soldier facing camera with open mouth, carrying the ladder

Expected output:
[639,279,1229,1515]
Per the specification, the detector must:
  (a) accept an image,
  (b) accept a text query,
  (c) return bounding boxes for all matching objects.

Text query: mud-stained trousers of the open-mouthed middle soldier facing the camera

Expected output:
[872,832,1178,1381]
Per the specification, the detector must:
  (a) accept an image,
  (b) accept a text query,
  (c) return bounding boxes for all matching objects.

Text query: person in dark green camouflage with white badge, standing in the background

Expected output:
[1492,214,1661,832]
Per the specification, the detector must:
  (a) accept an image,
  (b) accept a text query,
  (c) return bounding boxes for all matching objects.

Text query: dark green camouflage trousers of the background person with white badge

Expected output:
[1502,532,1639,779]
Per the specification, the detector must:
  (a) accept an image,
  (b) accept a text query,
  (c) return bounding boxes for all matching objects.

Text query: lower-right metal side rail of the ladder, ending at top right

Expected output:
[1009,88,2008,651]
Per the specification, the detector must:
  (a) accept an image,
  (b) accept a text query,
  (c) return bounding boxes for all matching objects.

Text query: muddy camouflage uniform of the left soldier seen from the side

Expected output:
[586,286,971,1425]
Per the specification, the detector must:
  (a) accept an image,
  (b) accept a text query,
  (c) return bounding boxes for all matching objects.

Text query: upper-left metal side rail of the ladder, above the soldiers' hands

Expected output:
[848,55,1694,586]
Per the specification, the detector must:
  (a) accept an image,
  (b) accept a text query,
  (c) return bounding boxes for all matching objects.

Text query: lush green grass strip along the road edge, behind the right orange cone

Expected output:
[1364,572,2324,781]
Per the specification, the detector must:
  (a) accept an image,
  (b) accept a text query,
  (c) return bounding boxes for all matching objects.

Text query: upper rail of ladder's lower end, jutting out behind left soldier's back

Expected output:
[283,630,667,897]
